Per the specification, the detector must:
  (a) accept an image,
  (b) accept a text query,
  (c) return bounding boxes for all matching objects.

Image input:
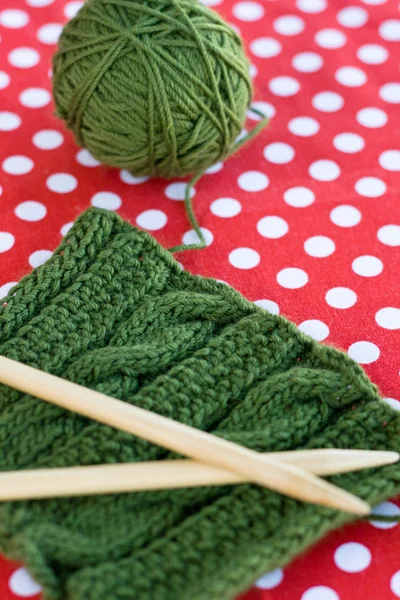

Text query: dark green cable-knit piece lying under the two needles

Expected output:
[0,209,400,600]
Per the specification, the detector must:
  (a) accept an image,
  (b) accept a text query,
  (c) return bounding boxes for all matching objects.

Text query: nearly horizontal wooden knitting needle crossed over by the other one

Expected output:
[0,449,399,501]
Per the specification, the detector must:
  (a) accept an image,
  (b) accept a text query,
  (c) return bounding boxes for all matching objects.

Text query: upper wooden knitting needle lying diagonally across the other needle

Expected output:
[0,356,371,515]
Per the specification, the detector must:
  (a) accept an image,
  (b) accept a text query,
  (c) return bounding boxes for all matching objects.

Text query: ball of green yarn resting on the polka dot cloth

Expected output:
[53,0,252,177]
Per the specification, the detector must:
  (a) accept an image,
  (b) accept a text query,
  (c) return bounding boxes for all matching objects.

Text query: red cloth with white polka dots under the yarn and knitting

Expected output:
[0,0,400,600]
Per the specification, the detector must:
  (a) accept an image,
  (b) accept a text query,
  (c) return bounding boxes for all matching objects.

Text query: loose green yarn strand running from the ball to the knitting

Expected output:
[169,108,269,253]
